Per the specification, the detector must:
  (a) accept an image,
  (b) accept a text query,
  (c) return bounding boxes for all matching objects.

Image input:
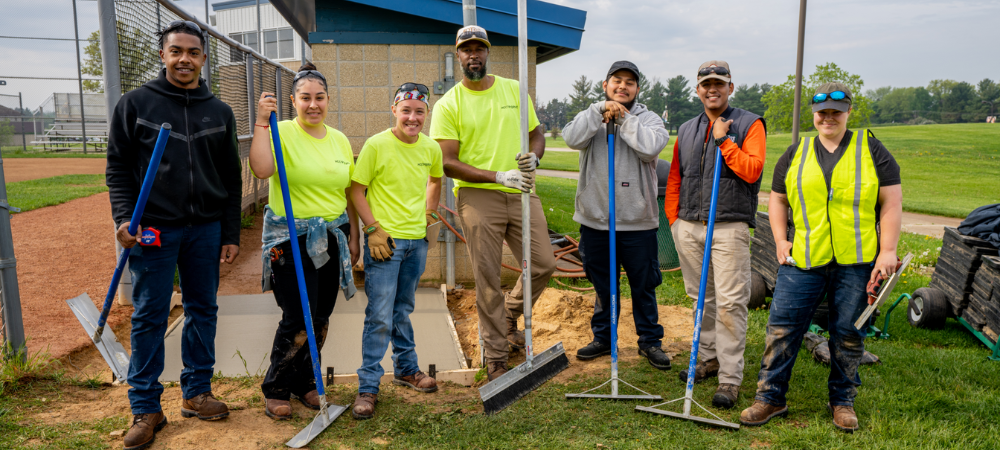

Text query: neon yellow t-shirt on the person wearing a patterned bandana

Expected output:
[351,129,444,239]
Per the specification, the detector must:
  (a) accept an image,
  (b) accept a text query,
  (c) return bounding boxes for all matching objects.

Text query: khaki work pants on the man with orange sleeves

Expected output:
[670,219,750,385]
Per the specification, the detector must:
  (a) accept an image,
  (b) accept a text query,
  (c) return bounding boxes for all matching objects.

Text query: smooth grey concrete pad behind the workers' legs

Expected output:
[160,289,465,382]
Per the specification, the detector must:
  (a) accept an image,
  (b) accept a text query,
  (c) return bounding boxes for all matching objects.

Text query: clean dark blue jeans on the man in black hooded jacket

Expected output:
[128,222,222,414]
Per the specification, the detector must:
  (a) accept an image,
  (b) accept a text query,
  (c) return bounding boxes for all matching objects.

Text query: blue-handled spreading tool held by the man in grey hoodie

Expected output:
[566,120,662,400]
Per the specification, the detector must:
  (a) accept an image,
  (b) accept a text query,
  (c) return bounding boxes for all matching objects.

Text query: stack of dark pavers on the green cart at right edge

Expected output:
[928,227,997,320]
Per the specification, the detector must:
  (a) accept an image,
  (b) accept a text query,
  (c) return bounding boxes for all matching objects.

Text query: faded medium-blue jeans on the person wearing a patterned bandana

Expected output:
[358,236,427,394]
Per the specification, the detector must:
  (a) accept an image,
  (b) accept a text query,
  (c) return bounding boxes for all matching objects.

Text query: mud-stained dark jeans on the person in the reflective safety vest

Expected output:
[756,263,872,406]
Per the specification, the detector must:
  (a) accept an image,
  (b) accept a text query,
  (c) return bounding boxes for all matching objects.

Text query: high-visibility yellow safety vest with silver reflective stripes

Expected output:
[785,130,878,269]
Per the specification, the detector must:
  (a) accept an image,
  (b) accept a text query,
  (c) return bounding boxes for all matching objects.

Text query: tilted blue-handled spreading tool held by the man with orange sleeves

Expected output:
[635,147,740,430]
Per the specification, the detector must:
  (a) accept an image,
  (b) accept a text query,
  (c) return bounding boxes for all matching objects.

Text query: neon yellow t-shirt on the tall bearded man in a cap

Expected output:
[431,75,539,193]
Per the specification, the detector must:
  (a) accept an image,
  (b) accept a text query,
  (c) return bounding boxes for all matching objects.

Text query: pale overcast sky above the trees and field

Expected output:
[0,0,1000,108]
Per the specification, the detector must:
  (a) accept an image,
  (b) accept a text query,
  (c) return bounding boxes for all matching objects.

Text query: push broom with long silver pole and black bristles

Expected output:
[479,0,569,415]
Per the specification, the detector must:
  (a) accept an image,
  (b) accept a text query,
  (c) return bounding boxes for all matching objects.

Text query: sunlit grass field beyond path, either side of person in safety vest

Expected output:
[761,124,1000,218]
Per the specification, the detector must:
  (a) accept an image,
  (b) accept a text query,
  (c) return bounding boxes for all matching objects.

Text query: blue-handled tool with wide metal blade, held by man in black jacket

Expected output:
[66,123,170,380]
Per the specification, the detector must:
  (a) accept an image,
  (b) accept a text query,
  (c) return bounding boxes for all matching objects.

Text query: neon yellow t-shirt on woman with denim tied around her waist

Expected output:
[266,119,354,221]
